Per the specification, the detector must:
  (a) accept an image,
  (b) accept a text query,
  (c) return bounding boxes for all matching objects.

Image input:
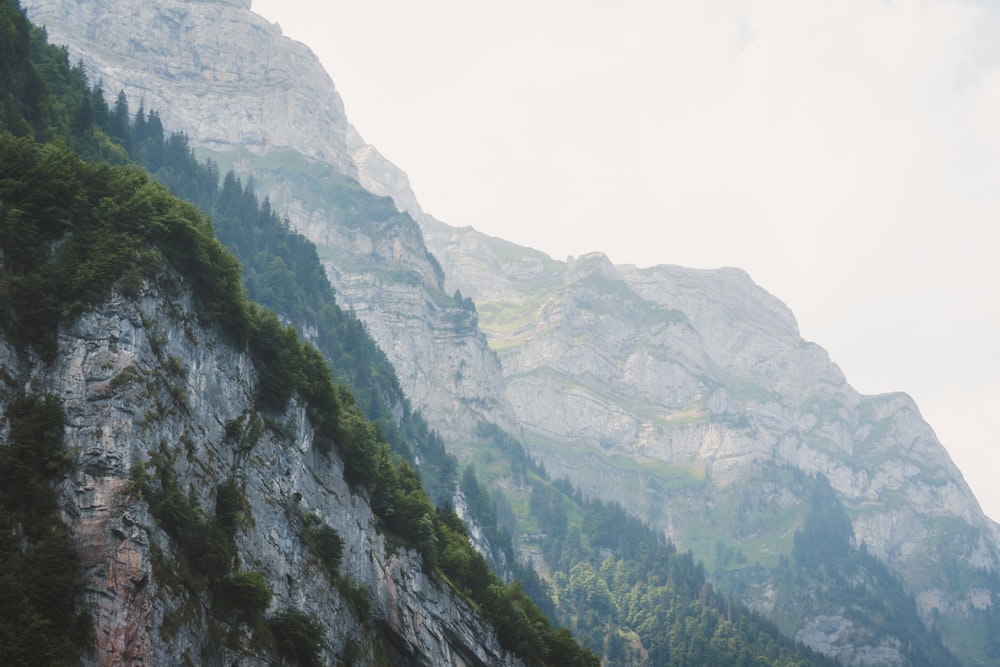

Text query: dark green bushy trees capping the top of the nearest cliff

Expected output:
[0,135,249,360]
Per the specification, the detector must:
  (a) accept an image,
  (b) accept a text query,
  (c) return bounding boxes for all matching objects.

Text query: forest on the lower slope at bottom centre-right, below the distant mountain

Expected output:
[531,479,835,665]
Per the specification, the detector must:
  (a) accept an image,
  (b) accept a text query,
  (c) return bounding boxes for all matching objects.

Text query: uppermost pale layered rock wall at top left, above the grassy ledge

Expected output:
[22,0,356,175]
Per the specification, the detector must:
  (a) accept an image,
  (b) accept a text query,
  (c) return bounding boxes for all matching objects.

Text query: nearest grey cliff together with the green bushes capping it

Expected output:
[0,138,544,665]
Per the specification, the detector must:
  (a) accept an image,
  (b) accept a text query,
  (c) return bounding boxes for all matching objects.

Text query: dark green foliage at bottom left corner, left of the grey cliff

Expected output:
[0,396,91,665]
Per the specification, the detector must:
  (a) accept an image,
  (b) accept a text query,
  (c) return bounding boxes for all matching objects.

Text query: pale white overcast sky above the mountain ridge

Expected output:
[253,0,1000,518]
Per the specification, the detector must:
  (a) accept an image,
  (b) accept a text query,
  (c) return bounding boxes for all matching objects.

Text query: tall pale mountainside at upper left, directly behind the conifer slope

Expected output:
[24,0,517,448]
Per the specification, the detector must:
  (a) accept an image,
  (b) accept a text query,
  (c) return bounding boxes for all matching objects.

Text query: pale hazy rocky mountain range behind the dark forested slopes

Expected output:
[17,0,1000,664]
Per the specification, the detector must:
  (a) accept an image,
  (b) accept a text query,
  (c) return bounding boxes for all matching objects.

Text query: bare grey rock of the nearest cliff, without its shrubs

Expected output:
[0,285,521,666]
